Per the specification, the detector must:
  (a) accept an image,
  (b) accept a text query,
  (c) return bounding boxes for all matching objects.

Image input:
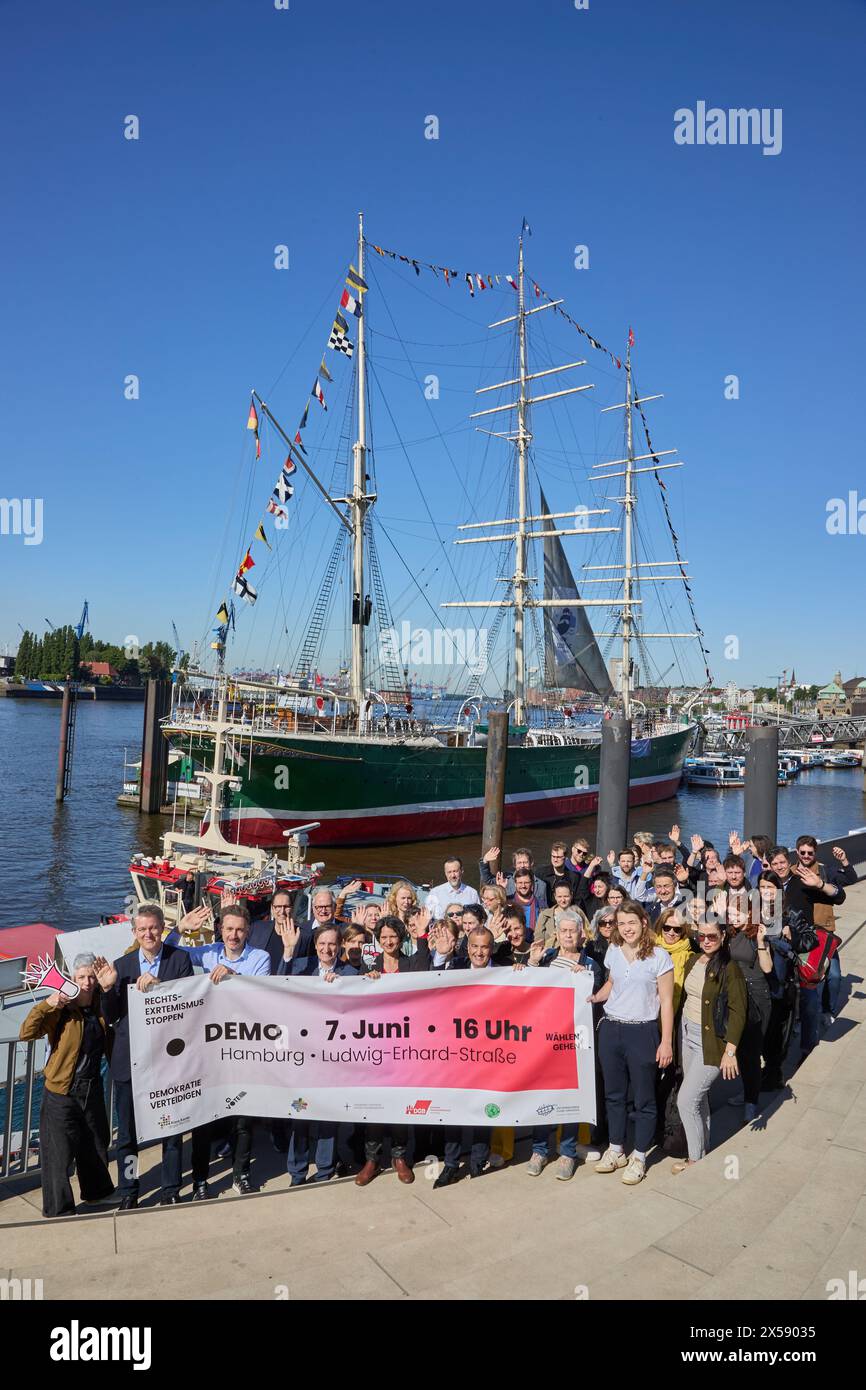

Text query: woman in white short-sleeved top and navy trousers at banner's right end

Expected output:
[591,901,674,1187]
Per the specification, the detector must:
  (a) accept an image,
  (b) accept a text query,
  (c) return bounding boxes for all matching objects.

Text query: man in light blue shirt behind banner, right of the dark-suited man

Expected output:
[186,904,271,1202]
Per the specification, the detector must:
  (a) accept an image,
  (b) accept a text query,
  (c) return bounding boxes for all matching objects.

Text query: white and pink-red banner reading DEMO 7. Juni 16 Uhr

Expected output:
[129,969,595,1141]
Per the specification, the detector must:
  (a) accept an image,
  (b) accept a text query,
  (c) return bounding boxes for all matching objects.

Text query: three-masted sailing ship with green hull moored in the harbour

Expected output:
[164,217,703,847]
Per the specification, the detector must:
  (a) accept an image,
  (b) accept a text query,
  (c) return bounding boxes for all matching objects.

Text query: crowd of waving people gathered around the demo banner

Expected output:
[21,826,855,1216]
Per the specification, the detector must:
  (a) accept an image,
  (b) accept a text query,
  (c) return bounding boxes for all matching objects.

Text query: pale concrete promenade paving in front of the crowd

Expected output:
[0,884,866,1301]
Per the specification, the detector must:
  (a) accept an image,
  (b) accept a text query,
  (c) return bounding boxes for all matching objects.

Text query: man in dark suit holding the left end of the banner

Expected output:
[95,902,195,1211]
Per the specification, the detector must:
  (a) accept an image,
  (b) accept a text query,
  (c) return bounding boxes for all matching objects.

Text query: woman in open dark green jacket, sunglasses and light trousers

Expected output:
[673,922,748,1173]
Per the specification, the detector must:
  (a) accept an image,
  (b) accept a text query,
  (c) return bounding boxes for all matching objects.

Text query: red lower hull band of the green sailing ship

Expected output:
[215,771,681,847]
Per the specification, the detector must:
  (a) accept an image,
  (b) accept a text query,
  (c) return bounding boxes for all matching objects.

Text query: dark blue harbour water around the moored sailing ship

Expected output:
[0,699,866,930]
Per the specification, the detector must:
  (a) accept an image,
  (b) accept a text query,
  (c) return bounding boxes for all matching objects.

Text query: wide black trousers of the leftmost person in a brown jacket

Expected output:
[39,1079,114,1216]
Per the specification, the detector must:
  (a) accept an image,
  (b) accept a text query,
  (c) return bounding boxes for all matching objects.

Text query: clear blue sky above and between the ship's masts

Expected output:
[0,0,866,695]
